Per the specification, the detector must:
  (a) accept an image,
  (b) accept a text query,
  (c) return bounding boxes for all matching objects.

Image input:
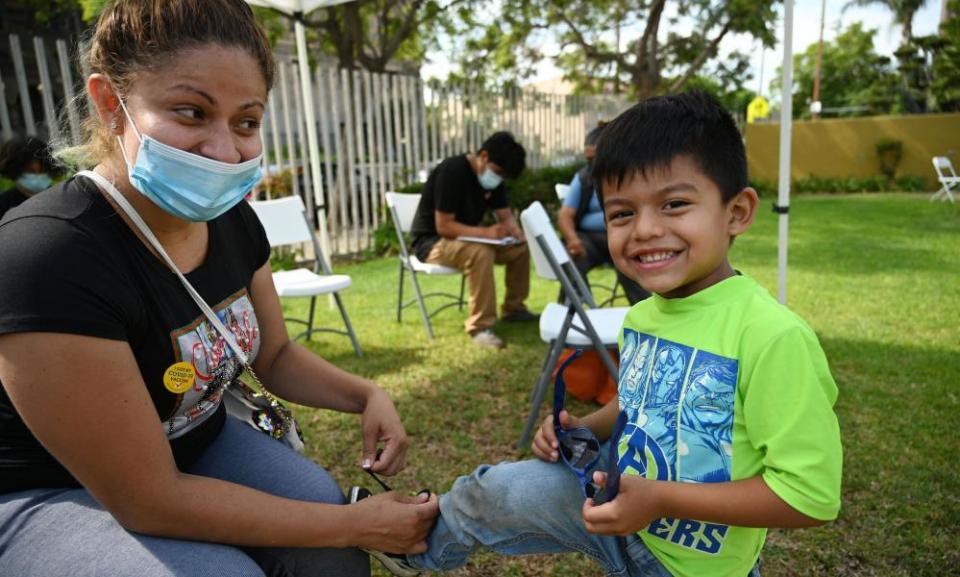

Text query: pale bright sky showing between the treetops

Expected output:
[423,0,941,97]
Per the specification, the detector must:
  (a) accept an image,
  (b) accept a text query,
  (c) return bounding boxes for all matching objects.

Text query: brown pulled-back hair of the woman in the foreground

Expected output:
[70,0,276,162]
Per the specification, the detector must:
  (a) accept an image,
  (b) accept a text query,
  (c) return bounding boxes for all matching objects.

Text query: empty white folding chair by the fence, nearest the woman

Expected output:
[250,195,363,357]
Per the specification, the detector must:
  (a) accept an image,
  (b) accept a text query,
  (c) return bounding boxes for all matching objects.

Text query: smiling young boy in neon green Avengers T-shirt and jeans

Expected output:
[378,93,842,577]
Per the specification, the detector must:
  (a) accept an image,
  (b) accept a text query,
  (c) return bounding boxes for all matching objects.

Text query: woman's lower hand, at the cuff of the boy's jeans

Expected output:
[350,491,440,553]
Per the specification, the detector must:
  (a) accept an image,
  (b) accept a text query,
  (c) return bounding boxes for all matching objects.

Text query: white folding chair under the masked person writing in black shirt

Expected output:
[386,192,467,339]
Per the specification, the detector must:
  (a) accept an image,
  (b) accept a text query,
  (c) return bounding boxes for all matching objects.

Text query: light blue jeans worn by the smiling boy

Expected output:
[407,443,760,577]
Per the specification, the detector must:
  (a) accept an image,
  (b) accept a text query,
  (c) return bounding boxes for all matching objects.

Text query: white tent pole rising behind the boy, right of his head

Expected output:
[774,0,793,304]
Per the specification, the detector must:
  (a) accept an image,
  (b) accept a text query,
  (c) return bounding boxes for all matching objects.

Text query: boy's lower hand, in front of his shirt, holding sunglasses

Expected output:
[582,471,664,535]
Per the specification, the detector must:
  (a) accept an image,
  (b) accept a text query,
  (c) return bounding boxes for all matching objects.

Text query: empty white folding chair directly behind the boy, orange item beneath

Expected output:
[518,202,630,447]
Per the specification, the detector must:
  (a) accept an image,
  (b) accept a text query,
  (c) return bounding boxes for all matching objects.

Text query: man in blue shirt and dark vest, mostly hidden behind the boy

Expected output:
[557,124,650,305]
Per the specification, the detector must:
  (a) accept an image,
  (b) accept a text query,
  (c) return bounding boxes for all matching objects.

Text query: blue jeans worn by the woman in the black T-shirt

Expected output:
[0,418,370,577]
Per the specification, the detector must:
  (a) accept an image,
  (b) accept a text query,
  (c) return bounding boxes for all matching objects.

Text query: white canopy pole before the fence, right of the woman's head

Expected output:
[247,0,351,257]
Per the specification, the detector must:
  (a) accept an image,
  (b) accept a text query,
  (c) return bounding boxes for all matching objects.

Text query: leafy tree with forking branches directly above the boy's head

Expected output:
[446,0,776,98]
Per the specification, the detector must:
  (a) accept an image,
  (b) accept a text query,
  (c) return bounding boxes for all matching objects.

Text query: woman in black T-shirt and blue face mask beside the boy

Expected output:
[0,0,438,577]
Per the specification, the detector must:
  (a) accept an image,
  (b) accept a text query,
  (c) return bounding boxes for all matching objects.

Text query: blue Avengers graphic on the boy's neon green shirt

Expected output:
[619,328,738,554]
